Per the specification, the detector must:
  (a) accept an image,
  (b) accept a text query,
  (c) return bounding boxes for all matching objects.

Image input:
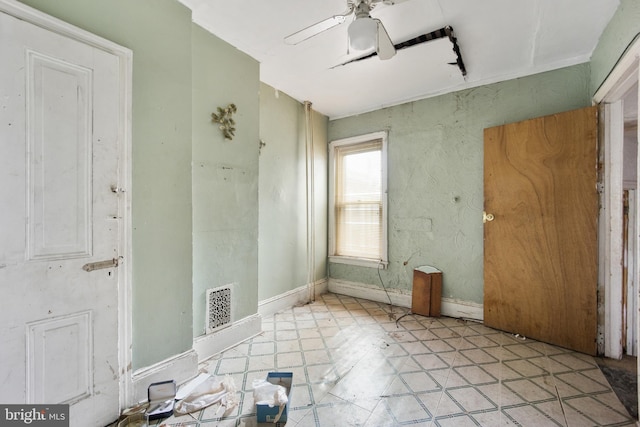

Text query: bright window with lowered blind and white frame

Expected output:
[329,132,387,267]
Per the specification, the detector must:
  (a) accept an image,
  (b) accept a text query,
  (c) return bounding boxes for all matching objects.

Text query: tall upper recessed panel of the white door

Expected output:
[25,50,92,260]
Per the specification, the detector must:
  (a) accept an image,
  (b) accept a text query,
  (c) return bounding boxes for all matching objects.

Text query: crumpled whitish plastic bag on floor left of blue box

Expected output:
[173,375,238,415]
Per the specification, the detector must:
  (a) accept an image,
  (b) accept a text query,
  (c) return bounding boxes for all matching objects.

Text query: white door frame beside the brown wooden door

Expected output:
[593,38,640,414]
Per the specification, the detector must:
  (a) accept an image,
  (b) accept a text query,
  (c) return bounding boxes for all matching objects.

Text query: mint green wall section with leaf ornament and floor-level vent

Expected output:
[192,25,260,336]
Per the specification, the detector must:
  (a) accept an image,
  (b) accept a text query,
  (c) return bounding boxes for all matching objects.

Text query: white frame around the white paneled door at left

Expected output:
[0,0,134,409]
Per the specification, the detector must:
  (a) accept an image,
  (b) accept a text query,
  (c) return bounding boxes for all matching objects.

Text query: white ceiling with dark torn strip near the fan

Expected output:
[180,0,619,119]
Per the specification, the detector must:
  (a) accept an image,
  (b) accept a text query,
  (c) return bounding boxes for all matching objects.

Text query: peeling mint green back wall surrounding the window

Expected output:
[329,64,591,303]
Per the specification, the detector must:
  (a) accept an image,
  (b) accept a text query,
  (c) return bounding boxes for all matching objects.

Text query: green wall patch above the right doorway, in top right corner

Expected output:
[591,0,640,94]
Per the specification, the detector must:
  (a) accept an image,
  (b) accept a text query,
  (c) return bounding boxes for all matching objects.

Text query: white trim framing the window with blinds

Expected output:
[329,131,389,268]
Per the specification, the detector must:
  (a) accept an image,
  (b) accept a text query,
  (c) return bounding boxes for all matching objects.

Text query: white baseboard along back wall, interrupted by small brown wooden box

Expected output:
[329,279,484,321]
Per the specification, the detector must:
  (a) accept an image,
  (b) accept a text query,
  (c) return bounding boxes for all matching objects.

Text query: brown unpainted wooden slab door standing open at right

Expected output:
[484,107,598,354]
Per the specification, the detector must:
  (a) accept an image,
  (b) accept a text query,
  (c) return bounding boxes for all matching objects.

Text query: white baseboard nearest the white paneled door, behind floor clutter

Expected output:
[128,349,198,405]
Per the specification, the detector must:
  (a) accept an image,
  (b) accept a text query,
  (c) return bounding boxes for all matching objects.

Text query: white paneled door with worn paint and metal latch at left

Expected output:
[0,7,122,427]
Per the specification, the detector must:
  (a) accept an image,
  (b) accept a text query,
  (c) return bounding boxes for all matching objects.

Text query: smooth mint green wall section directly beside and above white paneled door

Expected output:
[24,0,195,370]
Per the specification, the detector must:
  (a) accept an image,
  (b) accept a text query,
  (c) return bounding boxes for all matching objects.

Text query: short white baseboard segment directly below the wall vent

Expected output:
[193,314,262,362]
